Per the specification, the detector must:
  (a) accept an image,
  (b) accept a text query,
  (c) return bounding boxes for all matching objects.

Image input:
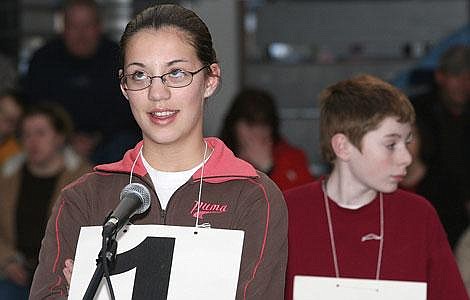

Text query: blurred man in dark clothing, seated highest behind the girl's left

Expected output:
[24,0,138,163]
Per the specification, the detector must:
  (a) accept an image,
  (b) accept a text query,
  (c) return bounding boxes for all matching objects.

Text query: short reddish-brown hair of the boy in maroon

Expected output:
[320,75,415,162]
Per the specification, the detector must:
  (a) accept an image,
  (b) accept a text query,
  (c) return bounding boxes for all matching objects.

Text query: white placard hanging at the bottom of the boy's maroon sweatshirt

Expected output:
[294,275,427,300]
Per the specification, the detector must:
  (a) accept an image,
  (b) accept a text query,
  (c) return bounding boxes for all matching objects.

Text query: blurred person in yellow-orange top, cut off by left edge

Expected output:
[0,89,23,166]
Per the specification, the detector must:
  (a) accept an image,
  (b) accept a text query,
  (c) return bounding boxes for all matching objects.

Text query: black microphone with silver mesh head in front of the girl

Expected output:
[102,183,150,237]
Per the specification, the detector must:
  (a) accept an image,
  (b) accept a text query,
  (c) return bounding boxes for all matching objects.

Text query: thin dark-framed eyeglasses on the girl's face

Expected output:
[121,65,209,91]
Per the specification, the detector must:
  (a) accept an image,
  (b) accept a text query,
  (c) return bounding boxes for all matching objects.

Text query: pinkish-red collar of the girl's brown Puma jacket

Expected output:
[94,137,259,183]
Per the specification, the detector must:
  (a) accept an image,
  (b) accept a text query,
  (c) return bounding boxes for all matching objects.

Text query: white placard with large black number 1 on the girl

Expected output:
[68,225,244,300]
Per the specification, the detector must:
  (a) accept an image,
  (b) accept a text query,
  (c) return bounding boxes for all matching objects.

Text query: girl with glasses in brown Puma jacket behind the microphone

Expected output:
[31,5,287,299]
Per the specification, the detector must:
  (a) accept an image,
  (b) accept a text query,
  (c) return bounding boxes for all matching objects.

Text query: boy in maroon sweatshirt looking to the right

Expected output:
[285,75,468,300]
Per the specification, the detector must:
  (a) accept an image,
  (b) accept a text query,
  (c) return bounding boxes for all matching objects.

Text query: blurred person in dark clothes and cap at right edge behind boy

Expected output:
[411,45,470,247]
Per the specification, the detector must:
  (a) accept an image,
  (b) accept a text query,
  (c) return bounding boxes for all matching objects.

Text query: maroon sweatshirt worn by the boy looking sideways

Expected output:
[285,181,468,300]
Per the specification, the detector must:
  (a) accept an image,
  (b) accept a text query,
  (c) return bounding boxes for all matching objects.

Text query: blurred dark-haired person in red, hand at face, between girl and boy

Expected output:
[221,89,315,190]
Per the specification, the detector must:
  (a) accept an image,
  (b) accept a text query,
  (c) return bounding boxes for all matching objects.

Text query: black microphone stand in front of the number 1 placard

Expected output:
[83,214,117,300]
